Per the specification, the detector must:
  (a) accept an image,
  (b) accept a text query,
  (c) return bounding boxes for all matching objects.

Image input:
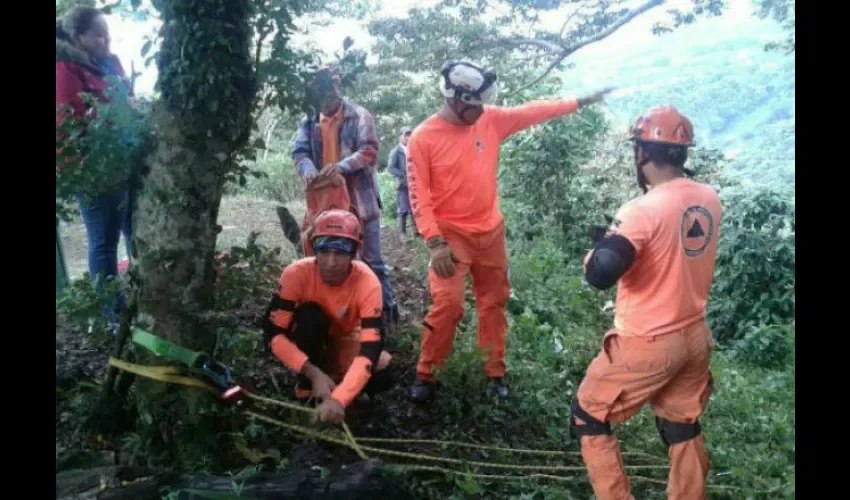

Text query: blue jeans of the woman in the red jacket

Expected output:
[77,191,132,316]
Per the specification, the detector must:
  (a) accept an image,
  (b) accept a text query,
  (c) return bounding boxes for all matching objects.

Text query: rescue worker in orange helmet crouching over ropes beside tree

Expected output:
[265,209,392,423]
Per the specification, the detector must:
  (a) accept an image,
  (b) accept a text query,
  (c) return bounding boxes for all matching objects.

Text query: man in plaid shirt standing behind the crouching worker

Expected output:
[292,68,399,322]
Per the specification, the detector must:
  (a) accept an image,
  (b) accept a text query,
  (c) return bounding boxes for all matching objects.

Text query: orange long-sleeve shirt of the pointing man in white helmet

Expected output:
[407,99,579,240]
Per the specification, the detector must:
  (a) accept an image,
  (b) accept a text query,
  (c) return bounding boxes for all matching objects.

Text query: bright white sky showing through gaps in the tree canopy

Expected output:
[108,0,753,95]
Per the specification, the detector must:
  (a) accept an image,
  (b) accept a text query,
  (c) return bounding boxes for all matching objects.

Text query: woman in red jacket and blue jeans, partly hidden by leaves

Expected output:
[56,7,131,324]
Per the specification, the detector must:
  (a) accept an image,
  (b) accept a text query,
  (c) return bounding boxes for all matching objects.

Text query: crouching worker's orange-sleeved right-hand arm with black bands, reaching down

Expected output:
[331,277,384,408]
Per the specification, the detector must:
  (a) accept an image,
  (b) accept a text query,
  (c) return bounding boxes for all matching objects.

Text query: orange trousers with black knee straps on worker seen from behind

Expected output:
[575,321,714,500]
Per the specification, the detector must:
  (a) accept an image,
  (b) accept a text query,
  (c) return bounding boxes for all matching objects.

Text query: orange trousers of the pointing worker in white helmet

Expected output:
[416,222,511,381]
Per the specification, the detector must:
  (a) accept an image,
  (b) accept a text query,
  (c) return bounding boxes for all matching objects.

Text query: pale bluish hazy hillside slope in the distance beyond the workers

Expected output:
[564,18,796,190]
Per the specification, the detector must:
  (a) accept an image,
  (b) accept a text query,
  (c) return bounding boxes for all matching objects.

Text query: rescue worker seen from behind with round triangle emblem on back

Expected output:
[570,106,722,500]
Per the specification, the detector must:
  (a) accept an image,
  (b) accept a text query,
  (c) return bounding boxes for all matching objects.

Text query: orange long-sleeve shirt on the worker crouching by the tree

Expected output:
[269,257,382,407]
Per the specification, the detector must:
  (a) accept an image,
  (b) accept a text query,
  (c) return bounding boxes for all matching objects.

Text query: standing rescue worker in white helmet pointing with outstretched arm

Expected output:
[407,62,608,402]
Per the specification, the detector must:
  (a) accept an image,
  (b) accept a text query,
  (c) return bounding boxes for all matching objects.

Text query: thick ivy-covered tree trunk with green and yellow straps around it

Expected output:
[128,0,255,466]
